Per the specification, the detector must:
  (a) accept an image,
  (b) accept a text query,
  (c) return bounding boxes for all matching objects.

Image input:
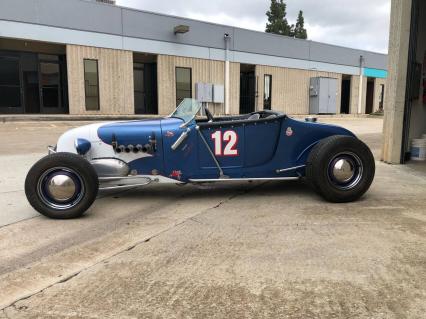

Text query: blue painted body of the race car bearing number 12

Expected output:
[97,113,354,182]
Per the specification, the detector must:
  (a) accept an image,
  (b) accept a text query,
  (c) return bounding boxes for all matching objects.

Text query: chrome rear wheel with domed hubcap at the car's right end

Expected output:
[328,152,364,190]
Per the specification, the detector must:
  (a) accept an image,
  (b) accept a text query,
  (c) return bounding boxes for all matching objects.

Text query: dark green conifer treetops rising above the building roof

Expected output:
[266,0,308,39]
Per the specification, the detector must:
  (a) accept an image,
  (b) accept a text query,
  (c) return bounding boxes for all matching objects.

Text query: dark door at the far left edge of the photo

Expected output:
[0,55,24,113]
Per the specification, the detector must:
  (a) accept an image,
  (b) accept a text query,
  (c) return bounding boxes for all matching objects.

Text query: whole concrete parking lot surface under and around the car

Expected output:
[0,118,426,318]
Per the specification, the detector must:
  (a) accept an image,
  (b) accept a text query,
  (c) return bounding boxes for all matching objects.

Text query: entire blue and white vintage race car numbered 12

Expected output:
[25,99,375,219]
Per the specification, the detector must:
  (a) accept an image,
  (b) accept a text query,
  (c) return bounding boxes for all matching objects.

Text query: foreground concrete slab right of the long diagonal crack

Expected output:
[6,170,426,318]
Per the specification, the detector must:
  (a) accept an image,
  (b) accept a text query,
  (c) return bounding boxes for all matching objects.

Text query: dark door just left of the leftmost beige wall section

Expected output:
[39,61,63,114]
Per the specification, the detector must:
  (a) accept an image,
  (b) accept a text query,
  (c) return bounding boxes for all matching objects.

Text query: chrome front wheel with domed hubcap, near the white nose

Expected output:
[37,167,85,210]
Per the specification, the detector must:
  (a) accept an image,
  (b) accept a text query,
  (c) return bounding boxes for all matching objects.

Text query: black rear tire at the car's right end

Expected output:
[306,135,376,203]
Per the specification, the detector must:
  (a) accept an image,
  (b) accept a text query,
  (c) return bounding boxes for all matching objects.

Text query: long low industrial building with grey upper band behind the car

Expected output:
[0,0,387,115]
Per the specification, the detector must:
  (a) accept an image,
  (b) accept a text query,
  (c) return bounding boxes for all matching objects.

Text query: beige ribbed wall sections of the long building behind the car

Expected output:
[66,45,384,115]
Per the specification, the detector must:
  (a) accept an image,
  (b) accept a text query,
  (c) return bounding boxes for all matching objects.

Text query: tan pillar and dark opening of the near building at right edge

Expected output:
[383,0,426,164]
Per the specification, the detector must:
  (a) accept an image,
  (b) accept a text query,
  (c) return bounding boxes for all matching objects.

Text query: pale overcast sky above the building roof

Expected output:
[117,0,390,53]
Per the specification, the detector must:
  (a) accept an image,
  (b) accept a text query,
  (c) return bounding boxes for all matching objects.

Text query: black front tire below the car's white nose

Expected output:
[25,153,99,219]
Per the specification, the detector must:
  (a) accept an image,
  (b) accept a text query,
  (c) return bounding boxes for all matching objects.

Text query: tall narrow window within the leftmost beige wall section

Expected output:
[84,59,99,111]
